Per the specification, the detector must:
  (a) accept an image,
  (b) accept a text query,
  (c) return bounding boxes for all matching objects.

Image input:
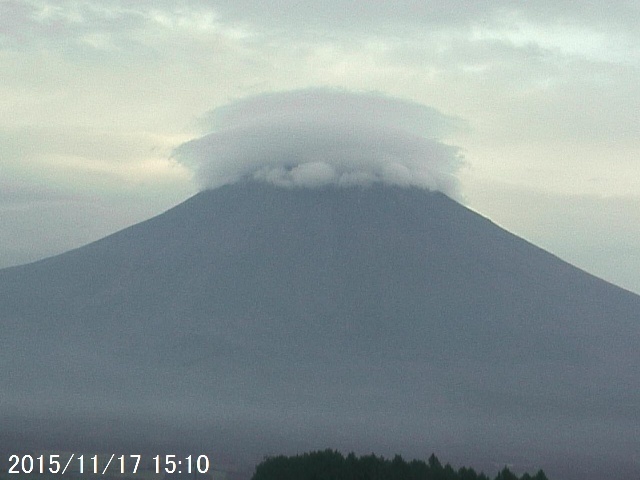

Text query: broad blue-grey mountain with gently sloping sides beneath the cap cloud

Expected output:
[0,182,640,480]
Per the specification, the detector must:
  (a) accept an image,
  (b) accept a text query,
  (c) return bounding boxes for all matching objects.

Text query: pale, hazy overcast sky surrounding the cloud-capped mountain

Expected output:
[0,0,640,292]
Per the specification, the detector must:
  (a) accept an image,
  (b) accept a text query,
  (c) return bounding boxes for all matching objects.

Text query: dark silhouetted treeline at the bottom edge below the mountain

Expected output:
[252,450,547,480]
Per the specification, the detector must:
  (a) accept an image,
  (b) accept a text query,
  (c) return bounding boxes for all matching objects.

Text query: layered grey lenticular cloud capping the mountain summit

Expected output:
[175,90,461,196]
